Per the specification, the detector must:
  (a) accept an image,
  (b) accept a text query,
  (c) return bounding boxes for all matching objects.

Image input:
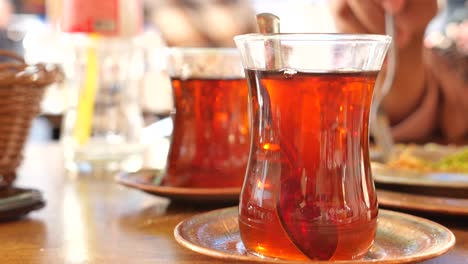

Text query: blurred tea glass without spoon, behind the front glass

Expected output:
[165,48,250,189]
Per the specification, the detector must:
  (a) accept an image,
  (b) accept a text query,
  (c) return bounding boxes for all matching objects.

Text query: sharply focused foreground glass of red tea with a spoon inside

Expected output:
[234,34,391,260]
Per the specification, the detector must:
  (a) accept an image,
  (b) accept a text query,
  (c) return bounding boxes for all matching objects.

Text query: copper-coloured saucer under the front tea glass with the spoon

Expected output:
[174,207,455,264]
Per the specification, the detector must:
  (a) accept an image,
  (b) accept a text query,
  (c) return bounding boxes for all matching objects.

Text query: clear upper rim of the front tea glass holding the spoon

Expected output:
[234,33,392,43]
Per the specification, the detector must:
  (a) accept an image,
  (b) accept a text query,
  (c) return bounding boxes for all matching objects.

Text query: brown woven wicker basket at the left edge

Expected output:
[0,50,59,188]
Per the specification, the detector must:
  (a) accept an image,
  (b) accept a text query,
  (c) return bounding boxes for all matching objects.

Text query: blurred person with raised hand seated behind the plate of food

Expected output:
[331,0,468,143]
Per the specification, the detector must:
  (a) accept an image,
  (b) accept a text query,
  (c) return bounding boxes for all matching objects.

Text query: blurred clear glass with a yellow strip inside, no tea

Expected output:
[62,35,144,174]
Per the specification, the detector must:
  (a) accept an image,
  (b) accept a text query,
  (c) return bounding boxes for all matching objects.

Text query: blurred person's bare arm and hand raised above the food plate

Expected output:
[331,0,437,141]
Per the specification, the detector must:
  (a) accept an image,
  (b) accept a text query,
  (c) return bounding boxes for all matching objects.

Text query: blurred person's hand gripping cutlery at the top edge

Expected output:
[331,0,437,47]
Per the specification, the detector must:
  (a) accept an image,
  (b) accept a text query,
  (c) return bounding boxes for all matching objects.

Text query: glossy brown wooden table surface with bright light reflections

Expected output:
[0,144,468,264]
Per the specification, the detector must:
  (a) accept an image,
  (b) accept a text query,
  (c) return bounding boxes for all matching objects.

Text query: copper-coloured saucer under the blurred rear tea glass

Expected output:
[116,169,241,203]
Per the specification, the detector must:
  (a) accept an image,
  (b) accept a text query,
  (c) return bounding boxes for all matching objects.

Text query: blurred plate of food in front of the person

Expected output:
[372,144,468,197]
